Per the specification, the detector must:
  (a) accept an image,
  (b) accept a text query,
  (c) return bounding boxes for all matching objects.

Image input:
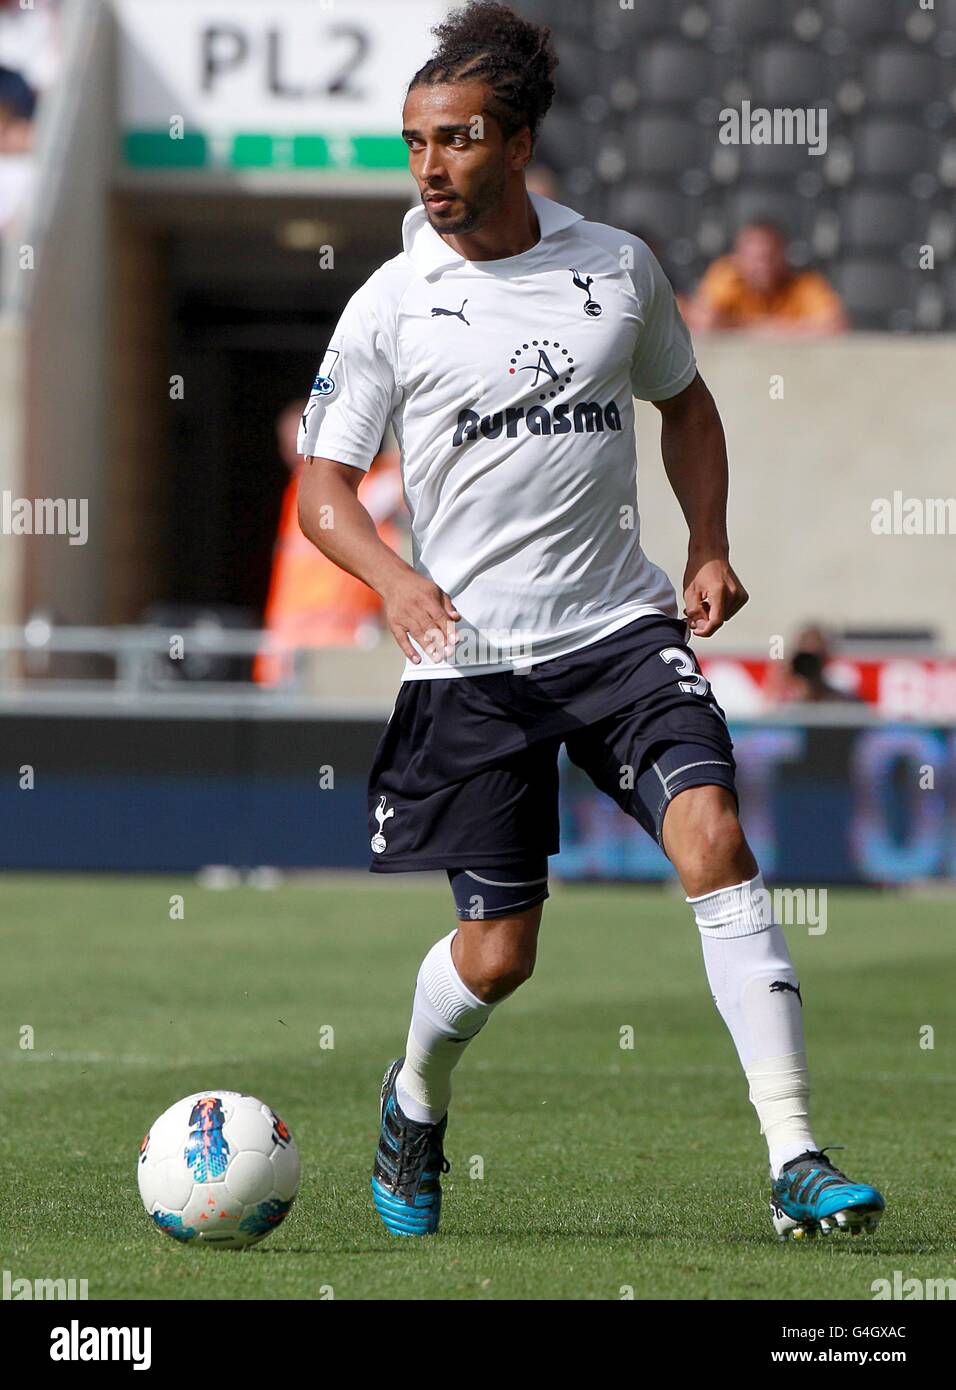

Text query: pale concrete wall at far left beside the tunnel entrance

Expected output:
[0,0,114,623]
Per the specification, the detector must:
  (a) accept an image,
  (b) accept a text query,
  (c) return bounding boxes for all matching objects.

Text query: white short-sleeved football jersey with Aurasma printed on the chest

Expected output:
[299,193,696,680]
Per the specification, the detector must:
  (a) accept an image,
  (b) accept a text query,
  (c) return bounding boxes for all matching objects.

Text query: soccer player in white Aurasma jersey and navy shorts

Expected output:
[299,0,884,1237]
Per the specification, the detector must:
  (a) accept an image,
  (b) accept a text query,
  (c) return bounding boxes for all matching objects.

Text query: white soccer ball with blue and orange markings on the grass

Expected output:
[136,1091,299,1250]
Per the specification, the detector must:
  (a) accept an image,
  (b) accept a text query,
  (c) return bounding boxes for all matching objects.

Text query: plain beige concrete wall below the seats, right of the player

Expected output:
[638,335,956,653]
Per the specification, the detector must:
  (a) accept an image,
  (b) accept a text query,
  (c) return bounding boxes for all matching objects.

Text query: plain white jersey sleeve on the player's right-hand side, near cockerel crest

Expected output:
[631,242,698,400]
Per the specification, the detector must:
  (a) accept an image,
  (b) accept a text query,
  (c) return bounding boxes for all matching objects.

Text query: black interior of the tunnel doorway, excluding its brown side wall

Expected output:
[149,200,407,623]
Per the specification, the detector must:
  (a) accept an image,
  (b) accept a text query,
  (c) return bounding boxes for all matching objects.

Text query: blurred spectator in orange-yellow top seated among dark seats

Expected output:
[685,222,849,338]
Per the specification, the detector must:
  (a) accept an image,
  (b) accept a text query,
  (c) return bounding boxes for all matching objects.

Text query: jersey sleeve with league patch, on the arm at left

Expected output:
[297,285,399,471]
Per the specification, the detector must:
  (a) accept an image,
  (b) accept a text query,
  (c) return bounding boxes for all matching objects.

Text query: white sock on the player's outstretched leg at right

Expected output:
[686,874,817,1177]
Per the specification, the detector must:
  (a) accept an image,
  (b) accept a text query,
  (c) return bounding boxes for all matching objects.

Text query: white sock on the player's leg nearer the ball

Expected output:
[395,927,495,1125]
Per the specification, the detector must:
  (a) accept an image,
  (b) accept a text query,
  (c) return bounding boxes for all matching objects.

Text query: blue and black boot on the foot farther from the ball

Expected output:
[770,1150,887,1240]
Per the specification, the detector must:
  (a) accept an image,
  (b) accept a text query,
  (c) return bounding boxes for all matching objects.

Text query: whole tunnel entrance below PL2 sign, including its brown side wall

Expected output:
[103,190,409,624]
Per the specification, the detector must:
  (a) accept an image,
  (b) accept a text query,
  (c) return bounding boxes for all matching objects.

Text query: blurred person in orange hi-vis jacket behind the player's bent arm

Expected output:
[253,400,407,685]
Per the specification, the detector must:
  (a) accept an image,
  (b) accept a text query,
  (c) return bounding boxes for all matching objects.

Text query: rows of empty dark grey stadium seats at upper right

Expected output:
[516,0,956,332]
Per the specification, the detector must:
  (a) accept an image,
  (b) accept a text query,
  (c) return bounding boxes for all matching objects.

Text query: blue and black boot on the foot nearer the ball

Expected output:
[372,1056,452,1236]
